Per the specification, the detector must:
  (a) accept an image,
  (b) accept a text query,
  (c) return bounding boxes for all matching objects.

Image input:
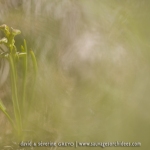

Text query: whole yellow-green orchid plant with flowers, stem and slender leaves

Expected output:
[0,24,37,137]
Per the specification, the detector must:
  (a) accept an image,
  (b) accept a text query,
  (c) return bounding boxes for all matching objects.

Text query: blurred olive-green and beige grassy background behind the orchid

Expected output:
[0,0,150,150]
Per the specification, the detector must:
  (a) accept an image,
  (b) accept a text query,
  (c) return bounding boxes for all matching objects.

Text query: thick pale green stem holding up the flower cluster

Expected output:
[9,53,22,136]
